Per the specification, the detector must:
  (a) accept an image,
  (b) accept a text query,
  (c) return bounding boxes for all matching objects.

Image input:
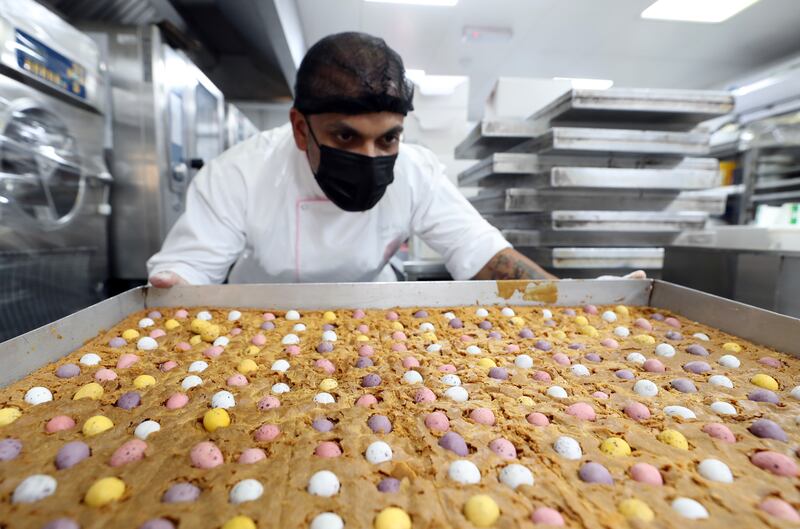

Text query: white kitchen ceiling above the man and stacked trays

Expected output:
[297,0,800,118]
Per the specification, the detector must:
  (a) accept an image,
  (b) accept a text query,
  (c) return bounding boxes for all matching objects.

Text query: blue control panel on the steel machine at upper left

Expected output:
[16,29,86,99]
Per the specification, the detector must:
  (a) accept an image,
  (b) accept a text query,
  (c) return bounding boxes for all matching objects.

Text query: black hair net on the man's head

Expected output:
[294,32,414,115]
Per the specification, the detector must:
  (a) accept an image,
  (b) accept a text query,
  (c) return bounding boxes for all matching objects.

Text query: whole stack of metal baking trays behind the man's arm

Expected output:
[455,89,733,277]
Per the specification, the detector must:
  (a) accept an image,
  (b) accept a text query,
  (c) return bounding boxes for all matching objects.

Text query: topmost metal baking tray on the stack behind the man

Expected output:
[528,88,734,131]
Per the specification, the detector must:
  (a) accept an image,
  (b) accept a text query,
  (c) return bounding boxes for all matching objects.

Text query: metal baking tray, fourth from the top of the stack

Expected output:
[469,188,727,215]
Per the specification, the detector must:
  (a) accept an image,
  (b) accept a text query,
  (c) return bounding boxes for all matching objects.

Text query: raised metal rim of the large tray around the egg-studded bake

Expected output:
[0,280,800,386]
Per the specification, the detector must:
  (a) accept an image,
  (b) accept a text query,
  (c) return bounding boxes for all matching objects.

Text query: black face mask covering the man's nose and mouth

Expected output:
[308,120,397,211]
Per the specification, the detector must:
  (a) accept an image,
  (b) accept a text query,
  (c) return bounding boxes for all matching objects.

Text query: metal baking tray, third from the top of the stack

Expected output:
[458,153,722,190]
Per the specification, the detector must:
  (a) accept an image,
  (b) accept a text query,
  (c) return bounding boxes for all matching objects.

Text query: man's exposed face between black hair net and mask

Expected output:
[289,108,405,172]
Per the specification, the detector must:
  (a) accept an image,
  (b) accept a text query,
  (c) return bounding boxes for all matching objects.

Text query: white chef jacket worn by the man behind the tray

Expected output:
[147,124,511,285]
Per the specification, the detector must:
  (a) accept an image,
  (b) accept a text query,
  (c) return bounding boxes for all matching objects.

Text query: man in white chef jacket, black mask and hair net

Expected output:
[147,33,640,288]
